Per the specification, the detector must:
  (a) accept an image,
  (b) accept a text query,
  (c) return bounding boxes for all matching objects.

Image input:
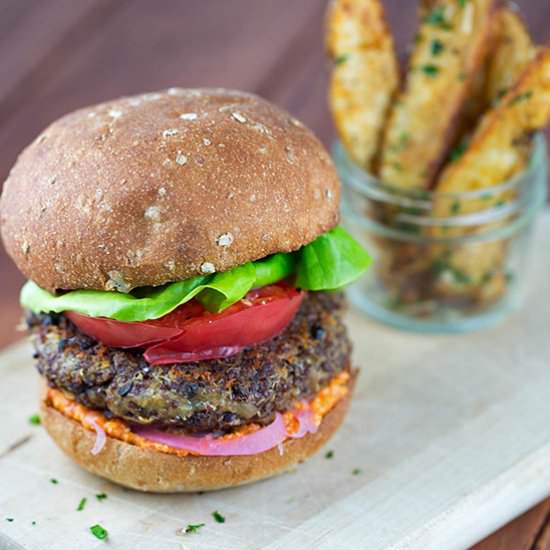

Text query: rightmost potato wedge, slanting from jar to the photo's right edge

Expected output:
[432,47,550,301]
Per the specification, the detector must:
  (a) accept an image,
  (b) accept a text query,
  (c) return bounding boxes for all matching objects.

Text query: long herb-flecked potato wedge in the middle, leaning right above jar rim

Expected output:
[380,0,495,189]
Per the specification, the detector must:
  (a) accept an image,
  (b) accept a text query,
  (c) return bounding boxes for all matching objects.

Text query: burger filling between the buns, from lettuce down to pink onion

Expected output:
[22,228,370,454]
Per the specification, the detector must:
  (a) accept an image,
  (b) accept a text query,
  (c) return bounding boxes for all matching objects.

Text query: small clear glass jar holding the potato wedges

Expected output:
[334,134,548,332]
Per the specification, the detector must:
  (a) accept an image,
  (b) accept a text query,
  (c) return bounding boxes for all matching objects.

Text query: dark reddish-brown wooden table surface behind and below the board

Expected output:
[0,0,550,550]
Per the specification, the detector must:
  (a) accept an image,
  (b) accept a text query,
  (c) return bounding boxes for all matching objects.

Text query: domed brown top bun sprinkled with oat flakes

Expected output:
[0,88,339,292]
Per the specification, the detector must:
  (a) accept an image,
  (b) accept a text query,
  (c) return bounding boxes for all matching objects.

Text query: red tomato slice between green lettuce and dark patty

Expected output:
[65,284,304,365]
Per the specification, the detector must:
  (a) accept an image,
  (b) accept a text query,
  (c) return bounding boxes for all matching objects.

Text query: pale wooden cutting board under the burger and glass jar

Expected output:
[0,214,550,550]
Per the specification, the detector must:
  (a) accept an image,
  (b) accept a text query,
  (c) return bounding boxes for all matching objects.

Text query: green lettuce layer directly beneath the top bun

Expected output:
[20,227,370,321]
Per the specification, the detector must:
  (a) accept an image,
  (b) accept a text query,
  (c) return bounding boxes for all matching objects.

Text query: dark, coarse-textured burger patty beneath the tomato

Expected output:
[28,293,351,432]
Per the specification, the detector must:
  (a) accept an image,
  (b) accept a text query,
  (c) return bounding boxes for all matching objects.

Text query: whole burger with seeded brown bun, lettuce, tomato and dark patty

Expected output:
[0,88,370,492]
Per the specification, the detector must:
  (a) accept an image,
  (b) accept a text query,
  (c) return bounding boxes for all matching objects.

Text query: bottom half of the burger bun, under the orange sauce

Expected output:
[42,377,355,493]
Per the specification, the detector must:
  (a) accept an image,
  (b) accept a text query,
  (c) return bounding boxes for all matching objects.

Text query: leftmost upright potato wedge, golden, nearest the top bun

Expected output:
[326,0,399,170]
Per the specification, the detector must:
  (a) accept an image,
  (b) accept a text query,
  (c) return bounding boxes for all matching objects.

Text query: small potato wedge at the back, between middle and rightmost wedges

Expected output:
[485,7,536,105]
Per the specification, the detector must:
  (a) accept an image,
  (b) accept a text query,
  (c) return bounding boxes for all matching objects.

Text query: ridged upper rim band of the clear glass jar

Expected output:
[333,132,547,242]
